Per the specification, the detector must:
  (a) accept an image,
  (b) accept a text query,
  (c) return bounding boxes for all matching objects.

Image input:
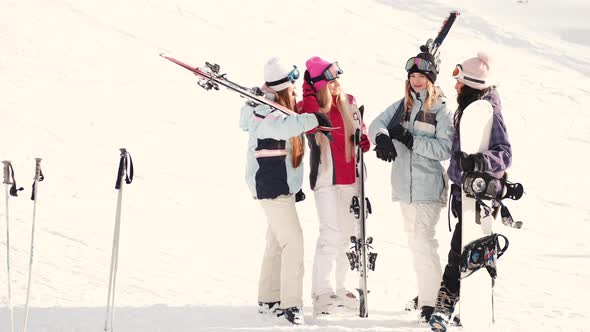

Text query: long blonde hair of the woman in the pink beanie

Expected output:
[315,85,359,162]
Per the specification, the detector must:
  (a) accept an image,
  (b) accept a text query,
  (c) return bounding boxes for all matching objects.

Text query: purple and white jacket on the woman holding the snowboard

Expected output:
[447,89,512,200]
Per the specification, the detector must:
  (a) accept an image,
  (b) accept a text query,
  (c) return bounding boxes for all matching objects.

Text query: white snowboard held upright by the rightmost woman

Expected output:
[459,100,493,331]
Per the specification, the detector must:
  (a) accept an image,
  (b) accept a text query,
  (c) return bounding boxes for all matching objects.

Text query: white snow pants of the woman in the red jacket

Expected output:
[311,184,358,298]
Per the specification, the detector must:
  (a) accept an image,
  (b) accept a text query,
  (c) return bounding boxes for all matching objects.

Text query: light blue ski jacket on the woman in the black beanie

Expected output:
[369,92,454,205]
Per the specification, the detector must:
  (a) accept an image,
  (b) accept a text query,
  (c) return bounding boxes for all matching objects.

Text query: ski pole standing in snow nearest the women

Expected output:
[104,148,133,332]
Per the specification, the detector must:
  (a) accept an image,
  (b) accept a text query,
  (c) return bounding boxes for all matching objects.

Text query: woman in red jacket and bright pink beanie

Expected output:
[302,57,370,315]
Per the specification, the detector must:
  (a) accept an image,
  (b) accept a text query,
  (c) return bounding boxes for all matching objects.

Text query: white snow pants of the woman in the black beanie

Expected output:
[400,203,442,308]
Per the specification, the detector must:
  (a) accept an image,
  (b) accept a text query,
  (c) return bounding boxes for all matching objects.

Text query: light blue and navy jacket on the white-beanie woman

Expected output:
[240,104,318,199]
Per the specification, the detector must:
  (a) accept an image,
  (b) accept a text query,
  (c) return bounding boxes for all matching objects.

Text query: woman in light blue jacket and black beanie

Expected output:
[369,53,454,322]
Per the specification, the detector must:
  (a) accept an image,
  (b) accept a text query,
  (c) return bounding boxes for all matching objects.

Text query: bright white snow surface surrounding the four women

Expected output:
[0,0,590,332]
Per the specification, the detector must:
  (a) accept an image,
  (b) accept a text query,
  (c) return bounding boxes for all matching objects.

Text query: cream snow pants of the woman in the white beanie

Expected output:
[258,195,303,308]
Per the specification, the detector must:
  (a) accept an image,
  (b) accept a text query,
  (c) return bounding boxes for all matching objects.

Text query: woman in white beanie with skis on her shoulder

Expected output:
[240,58,331,324]
